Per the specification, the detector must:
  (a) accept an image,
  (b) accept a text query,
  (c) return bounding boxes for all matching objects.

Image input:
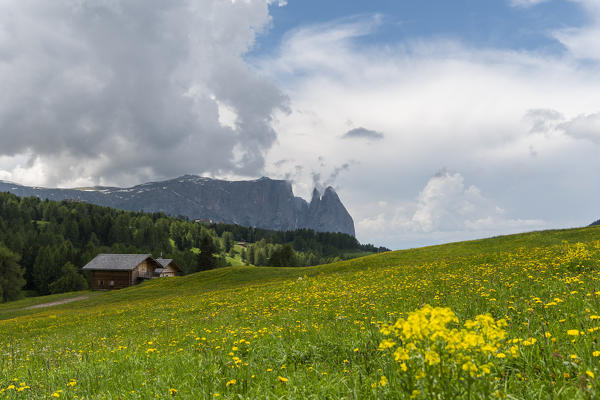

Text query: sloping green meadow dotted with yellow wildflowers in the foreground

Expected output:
[0,227,600,399]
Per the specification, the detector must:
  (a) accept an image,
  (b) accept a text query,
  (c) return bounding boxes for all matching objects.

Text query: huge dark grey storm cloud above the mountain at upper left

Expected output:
[0,0,287,184]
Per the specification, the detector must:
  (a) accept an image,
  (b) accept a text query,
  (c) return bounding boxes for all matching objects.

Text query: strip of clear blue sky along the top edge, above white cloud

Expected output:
[251,0,588,56]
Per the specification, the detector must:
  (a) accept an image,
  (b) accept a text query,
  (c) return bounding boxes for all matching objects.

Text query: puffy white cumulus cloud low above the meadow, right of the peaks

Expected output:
[357,172,549,248]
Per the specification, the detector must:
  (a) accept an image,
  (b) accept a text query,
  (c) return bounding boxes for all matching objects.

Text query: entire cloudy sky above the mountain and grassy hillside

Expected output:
[0,0,600,249]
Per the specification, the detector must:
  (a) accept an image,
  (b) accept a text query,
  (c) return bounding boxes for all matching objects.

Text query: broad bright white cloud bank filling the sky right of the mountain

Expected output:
[260,14,600,247]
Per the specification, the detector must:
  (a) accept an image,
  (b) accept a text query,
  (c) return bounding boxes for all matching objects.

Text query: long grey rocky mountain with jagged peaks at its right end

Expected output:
[0,175,355,236]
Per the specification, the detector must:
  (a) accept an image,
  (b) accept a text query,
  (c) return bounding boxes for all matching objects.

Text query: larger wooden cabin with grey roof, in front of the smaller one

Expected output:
[82,254,163,290]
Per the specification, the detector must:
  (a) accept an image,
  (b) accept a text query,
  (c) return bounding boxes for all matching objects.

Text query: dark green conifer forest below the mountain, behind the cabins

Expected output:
[0,193,388,301]
